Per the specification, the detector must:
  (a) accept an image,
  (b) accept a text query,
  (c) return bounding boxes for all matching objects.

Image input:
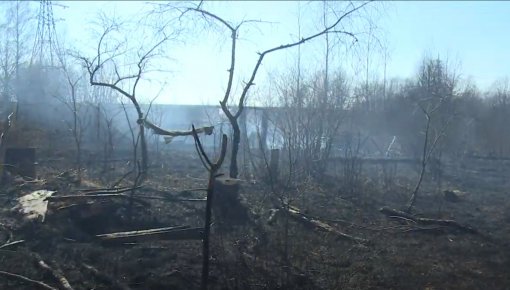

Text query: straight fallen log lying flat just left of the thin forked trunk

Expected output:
[96,226,204,243]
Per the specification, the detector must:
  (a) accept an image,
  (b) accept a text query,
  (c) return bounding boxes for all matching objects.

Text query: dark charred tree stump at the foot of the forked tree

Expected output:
[213,176,249,227]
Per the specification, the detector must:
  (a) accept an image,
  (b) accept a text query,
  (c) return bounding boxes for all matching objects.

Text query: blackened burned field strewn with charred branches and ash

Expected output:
[0,139,510,289]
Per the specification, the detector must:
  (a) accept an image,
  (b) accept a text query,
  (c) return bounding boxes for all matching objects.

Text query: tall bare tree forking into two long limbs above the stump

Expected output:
[166,2,369,178]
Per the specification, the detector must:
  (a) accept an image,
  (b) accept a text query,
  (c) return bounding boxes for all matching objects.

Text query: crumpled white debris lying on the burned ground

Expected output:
[12,190,55,222]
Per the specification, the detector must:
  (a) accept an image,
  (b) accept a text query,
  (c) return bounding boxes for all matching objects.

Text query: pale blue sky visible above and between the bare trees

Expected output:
[46,1,510,104]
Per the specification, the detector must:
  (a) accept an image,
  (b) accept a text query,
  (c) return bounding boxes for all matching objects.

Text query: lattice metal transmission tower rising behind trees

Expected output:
[30,0,62,68]
